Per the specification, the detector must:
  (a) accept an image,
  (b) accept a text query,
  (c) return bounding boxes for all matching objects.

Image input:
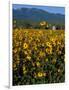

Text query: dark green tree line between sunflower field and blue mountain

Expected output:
[13,20,65,30]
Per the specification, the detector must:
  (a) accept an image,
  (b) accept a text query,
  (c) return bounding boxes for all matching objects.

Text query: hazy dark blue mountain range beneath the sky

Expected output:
[13,8,65,25]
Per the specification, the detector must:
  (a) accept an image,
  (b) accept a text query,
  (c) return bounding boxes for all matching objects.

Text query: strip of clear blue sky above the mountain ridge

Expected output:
[13,4,65,14]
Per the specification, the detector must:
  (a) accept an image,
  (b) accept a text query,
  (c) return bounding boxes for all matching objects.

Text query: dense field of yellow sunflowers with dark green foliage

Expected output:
[12,29,65,86]
